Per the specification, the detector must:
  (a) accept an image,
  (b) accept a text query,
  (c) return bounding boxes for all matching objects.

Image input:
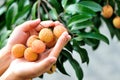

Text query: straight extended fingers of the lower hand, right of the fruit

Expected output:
[49,32,71,58]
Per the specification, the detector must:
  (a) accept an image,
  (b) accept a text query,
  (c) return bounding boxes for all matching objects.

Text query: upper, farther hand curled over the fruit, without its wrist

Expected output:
[7,19,58,49]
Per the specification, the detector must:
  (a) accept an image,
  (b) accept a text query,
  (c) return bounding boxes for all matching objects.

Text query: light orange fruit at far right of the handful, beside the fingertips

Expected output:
[53,25,67,38]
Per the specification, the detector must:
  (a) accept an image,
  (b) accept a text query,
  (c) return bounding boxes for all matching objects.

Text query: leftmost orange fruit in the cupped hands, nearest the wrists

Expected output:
[11,44,26,58]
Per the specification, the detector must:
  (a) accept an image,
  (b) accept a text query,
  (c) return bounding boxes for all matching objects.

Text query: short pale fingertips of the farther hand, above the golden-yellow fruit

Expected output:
[36,21,55,31]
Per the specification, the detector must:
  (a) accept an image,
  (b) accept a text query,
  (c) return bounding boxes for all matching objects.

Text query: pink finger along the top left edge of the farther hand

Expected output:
[20,19,40,32]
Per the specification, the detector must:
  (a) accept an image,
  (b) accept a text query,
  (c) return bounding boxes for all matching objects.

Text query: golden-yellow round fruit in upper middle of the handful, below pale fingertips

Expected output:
[39,28,54,43]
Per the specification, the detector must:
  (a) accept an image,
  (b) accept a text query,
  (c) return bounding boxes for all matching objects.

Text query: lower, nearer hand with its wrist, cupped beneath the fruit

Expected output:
[2,32,71,80]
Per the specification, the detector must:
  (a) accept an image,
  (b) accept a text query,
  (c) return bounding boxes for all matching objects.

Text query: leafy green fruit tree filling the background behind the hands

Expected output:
[0,0,120,80]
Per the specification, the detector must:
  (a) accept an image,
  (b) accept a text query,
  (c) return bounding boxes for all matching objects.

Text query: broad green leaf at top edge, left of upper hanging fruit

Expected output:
[80,1,102,12]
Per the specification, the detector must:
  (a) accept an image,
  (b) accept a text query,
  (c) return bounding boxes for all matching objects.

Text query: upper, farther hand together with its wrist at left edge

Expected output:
[0,19,55,75]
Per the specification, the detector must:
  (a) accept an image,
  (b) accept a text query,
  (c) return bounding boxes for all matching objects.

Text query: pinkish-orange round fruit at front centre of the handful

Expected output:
[31,40,46,54]
